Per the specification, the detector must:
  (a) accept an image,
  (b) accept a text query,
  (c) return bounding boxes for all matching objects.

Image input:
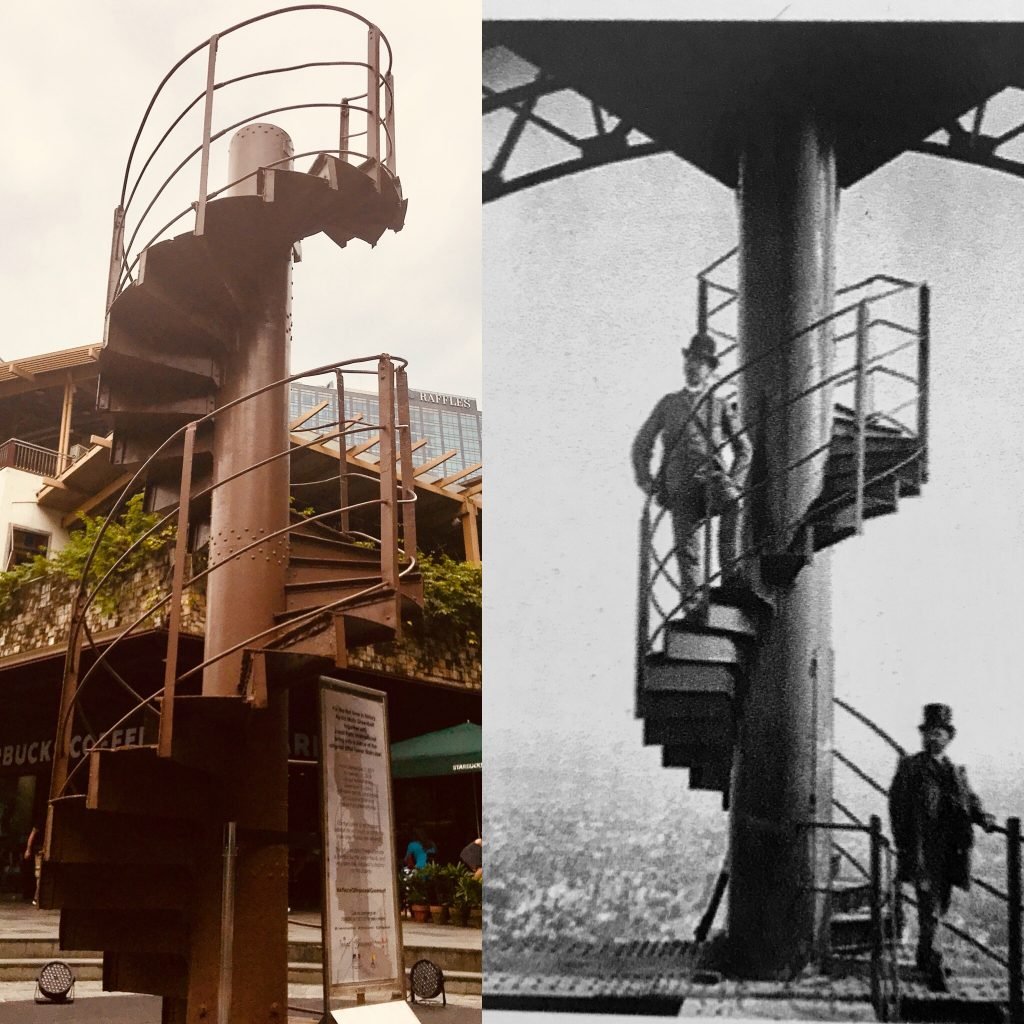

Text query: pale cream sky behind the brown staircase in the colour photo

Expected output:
[0,0,481,397]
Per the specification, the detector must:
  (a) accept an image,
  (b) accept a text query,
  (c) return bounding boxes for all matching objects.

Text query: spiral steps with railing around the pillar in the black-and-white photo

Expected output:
[636,253,929,807]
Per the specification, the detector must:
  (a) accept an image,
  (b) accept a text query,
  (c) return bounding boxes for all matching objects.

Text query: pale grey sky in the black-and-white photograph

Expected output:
[484,11,1024,798]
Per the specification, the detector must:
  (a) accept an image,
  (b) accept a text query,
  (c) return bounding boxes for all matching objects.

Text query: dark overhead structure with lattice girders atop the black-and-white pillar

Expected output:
[483,22,1024,193]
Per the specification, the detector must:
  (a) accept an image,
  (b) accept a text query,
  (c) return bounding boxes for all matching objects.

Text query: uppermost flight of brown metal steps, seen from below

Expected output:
[99,156,404,445]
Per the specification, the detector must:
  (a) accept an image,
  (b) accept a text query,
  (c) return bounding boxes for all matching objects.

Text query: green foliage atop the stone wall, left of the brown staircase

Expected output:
[0,492,175,614]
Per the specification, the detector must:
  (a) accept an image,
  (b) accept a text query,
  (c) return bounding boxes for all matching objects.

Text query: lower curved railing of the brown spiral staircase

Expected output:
[50,355,421,800]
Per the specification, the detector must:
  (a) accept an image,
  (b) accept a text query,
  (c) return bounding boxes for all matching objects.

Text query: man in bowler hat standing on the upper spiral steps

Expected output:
[633,334,751,610]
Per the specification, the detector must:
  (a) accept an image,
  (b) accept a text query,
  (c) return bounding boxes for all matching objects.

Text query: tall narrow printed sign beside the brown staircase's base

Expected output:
[319,679,404,995]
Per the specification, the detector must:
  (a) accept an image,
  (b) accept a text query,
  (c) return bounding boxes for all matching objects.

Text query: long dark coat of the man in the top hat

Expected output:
[889,751,985,889]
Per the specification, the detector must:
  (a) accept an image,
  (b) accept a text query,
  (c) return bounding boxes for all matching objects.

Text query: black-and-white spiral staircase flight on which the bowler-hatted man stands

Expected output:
[636,261,928,807]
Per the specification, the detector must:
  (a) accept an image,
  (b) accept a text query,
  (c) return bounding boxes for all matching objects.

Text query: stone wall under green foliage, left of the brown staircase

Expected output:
[0,549,206,658]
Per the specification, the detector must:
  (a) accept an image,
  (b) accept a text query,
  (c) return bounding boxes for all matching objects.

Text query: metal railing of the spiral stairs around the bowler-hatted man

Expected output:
[637,250,930,670]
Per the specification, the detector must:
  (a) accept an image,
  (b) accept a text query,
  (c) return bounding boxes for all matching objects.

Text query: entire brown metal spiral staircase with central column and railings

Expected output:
[40,14,422,1007]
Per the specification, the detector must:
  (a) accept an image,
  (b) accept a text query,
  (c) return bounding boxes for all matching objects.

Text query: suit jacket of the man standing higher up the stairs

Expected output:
[633,388,751,505]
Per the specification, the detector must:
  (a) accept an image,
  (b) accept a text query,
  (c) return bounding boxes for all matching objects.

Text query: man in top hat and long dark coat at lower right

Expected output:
[889,703,994,991]
